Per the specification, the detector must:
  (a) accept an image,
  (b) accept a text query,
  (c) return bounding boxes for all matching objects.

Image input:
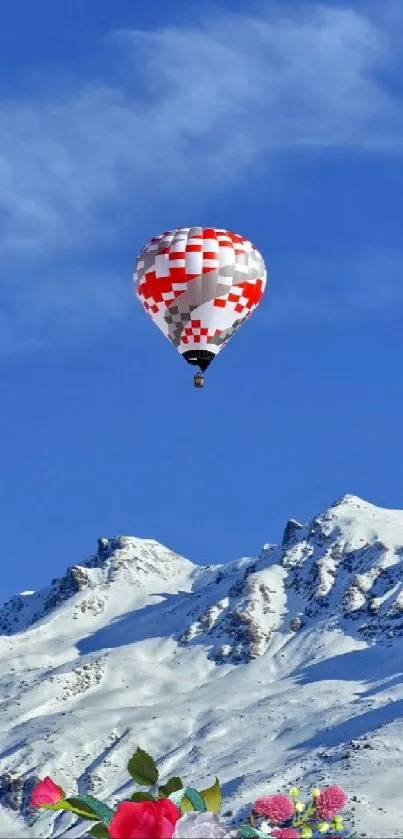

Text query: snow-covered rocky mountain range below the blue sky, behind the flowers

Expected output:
[0,496,403,837]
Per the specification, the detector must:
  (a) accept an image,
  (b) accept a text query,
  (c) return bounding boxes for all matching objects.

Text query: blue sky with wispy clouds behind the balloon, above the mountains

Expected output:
[0,0,403,599]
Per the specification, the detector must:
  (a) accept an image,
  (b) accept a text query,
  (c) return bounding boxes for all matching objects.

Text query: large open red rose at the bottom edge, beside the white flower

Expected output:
[108,798,180,839]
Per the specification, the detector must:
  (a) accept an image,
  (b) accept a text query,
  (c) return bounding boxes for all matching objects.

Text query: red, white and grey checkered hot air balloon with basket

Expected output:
[133,227,267,388]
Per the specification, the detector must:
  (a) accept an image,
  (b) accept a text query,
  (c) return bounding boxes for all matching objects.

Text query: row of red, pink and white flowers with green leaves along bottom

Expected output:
[31,748,353,839]
